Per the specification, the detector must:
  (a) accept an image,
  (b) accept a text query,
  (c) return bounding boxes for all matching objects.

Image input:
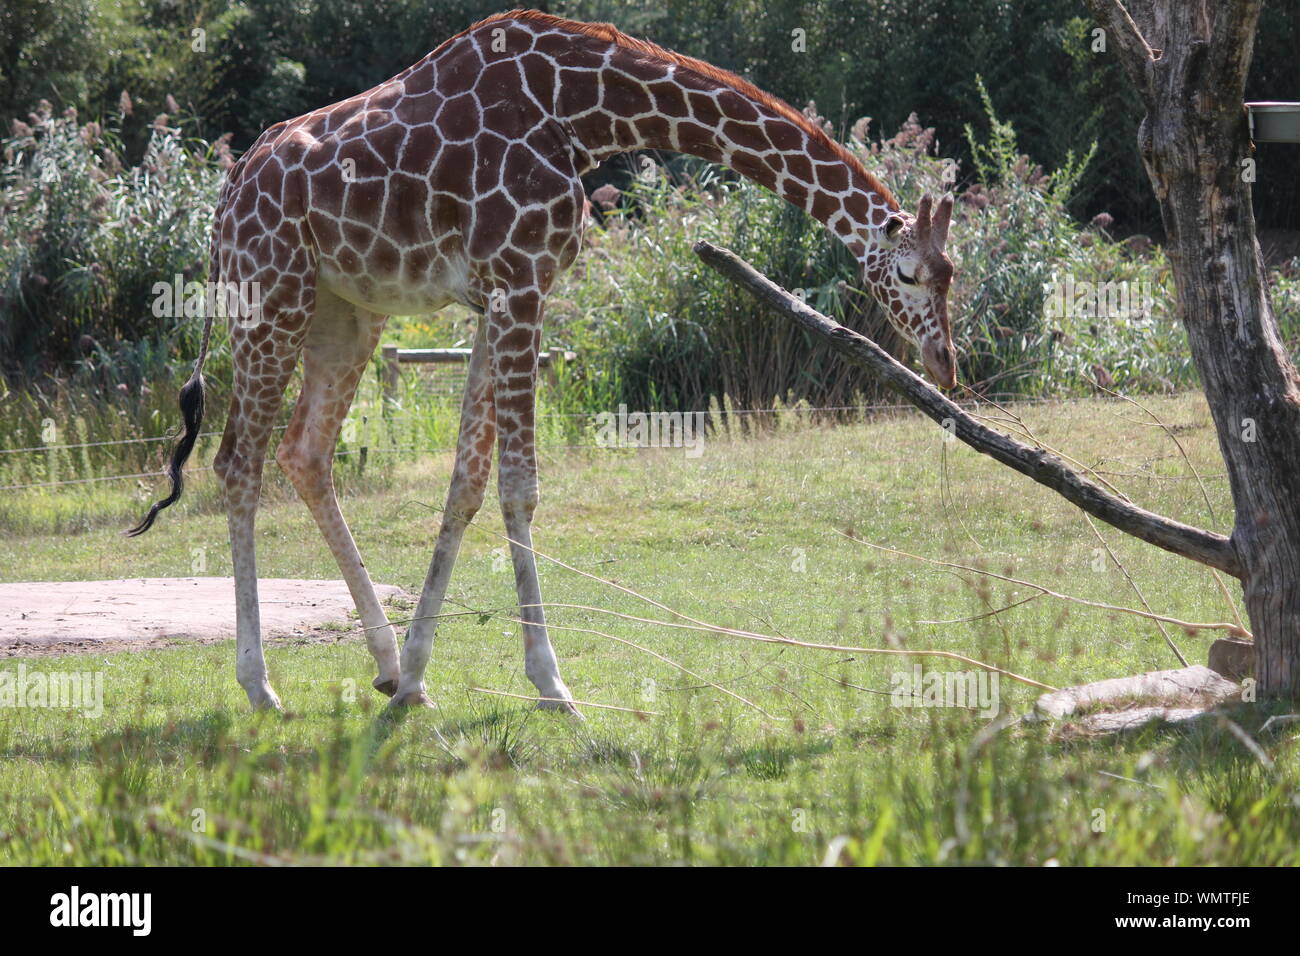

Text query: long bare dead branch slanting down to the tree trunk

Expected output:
[694,242,1243,578]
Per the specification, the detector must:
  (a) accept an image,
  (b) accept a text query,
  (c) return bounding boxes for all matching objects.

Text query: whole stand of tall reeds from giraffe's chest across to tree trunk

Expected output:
[549,87,1195,410]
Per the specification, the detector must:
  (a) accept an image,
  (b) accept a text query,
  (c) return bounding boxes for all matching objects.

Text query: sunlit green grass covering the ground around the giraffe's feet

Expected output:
[0,395,1300,865]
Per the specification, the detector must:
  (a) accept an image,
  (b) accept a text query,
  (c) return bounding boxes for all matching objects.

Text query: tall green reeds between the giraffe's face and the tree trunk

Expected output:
[948,77,1196,397]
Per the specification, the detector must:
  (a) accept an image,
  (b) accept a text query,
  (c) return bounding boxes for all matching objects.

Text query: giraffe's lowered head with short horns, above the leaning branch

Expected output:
[863,195,957,389]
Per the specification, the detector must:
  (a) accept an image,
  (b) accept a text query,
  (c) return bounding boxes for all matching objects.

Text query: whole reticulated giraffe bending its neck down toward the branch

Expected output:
[127,10,956,713]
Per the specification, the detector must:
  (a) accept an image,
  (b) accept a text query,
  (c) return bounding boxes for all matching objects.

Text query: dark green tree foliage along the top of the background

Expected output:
[0,0,1300,232]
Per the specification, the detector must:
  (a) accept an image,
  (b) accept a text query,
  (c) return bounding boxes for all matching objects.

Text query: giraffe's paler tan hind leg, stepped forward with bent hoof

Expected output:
[276,290,399,697]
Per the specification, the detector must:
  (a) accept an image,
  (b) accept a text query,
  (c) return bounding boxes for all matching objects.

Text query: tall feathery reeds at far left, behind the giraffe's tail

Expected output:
[0,101,224,392]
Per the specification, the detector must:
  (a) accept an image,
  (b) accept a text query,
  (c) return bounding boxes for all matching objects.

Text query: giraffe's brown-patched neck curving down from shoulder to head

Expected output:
[555,38,898,258]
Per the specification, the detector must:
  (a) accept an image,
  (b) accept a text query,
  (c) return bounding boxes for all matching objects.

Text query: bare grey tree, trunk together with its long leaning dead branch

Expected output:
[696,0,1300,697]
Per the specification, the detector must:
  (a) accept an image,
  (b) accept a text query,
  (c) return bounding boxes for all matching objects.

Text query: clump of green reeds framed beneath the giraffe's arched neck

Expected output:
[547,141,901,410]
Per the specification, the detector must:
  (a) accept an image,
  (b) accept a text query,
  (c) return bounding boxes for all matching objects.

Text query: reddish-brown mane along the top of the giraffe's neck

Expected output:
[473,9,898,209]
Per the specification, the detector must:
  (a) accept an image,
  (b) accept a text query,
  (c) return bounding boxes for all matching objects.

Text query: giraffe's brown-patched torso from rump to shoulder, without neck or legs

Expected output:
[218,17,584,313]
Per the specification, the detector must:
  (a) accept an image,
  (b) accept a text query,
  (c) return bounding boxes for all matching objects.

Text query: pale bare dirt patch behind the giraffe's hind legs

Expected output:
[0,578,403,658]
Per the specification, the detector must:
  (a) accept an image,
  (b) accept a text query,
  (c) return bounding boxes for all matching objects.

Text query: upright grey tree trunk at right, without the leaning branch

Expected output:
[1089,0,1300,697]
